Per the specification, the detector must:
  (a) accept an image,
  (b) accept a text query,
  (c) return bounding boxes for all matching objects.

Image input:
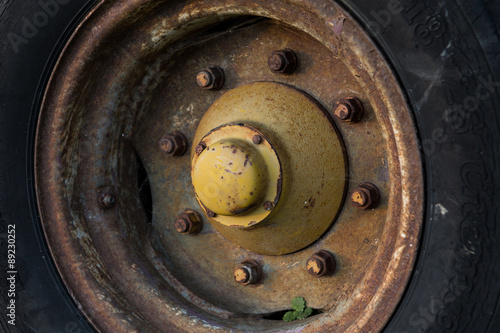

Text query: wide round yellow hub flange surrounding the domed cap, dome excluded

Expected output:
[191,82,347,255]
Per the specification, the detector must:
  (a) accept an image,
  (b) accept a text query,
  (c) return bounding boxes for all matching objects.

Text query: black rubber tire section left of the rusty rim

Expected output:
[0,0,99,333]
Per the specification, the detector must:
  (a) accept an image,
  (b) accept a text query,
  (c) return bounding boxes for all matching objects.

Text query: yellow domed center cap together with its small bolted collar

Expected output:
[191,124,282,228]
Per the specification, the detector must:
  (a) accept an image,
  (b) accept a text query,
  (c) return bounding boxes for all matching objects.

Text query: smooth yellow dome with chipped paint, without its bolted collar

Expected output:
[192,140,268,216]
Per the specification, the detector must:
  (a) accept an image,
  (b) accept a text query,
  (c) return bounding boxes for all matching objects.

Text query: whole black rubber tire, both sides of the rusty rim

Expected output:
[0,0,500,333]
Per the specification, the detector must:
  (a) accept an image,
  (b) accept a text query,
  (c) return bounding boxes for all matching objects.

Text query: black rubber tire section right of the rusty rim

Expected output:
[348,0,500,333]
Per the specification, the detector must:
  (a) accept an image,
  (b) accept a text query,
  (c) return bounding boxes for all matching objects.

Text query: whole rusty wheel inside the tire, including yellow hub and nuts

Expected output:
[35,0,423,333]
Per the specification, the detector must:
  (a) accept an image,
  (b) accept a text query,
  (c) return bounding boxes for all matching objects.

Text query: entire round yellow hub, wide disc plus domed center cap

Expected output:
[191,82,347,255]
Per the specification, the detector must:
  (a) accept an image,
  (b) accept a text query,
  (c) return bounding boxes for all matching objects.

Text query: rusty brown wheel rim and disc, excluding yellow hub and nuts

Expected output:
[36,1,423,332]
